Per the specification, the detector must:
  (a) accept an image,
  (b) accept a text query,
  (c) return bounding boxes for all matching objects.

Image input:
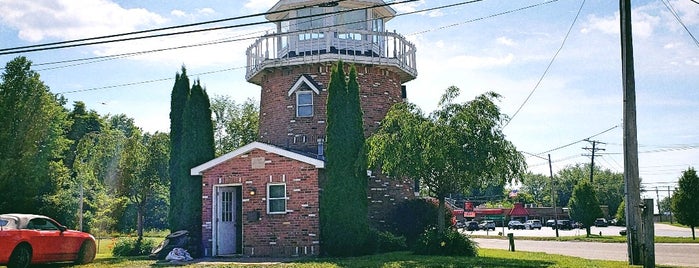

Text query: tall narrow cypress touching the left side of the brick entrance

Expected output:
[180,81,215,255]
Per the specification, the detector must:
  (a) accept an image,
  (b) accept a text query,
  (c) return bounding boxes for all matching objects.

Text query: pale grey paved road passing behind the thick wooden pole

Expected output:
[465,224,699,267]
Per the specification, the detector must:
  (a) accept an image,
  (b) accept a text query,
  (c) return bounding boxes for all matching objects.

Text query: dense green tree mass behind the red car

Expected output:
[0,57,167,234]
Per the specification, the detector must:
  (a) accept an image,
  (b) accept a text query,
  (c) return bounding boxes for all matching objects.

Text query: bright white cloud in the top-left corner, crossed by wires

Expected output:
[0,0,165,42]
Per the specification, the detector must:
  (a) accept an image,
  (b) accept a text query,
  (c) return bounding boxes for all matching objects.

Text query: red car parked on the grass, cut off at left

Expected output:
[0,214,96,268]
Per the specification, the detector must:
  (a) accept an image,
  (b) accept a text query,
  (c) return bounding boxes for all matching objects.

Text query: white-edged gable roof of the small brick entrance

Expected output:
[190,141,325,176]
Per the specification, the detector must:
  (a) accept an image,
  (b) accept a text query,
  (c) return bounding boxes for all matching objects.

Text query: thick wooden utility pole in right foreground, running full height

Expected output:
[619,0,652,265]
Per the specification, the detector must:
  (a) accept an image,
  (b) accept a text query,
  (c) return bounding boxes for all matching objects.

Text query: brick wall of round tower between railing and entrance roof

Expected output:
[259,63,403,153]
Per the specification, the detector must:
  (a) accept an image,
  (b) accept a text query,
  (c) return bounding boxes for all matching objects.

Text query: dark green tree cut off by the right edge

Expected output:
[672,167,699,239]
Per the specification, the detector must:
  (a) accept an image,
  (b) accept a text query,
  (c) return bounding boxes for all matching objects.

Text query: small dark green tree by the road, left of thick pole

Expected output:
[568,180,602,237]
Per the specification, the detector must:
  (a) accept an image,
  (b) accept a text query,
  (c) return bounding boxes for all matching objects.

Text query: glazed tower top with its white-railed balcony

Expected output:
[245,0,417,85]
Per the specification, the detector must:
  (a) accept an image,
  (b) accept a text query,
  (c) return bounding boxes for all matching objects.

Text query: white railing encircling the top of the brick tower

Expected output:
[245,29,417,81]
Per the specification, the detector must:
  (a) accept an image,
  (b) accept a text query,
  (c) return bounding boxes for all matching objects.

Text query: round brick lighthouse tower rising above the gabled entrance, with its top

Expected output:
[246,0,417,154]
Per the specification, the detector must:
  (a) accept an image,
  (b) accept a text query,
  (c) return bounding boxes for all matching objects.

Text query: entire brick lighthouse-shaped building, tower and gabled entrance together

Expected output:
[192,0,417,256]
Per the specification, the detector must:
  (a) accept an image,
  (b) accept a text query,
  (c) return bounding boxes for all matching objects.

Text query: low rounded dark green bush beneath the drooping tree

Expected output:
[413,228,478,257]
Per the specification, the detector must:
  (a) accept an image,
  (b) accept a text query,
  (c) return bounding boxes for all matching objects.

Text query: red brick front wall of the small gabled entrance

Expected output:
[202,149,321,256]
